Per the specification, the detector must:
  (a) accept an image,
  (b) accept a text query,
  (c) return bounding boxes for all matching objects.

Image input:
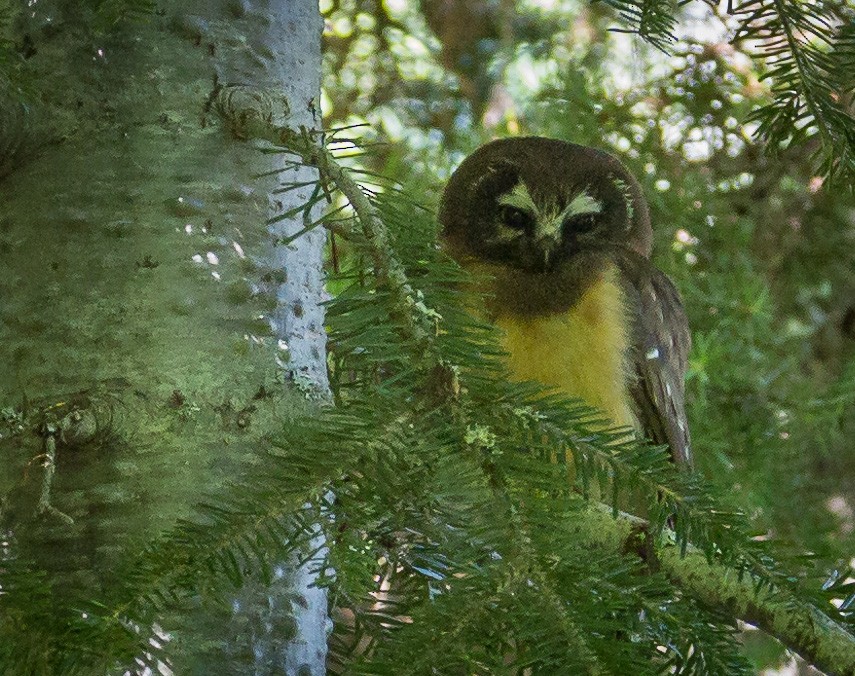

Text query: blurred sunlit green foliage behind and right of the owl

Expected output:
[321,0,855,596]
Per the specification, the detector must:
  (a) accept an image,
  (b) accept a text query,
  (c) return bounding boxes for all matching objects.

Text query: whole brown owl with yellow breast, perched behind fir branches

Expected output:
[439,137,692,466]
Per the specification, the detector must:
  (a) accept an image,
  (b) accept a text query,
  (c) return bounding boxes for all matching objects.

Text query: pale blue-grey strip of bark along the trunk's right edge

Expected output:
[218,0,330,674]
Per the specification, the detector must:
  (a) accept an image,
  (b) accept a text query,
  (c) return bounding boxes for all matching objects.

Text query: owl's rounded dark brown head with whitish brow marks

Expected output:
[439,137,652,273]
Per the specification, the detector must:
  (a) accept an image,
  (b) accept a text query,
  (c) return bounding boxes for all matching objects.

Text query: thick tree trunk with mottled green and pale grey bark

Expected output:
[0,0,327,673]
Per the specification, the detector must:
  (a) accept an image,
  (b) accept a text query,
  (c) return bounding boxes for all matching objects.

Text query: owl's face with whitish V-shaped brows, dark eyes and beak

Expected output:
[487,181,603,272]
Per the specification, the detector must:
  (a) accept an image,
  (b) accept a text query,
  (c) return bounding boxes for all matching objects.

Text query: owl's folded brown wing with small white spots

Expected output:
[630,265,692,467]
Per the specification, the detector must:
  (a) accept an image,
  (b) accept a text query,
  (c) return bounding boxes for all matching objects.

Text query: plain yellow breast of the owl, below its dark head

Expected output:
[495,267,638,429]
